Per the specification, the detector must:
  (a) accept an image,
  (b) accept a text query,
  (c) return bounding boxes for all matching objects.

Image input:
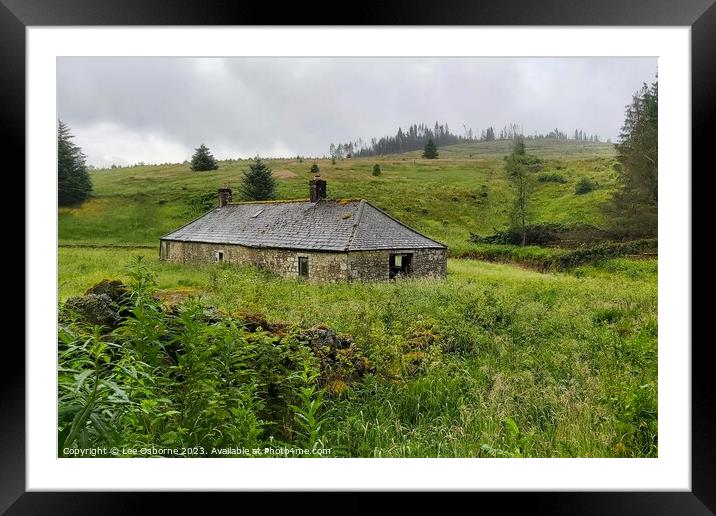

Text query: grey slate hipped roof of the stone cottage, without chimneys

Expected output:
[161,199,446,251]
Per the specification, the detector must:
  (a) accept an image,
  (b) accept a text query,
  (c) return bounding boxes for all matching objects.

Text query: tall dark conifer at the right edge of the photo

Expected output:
[605,78,659,236]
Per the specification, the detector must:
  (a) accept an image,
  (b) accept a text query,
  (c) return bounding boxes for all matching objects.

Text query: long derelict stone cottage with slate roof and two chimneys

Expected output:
[160,179,447,281]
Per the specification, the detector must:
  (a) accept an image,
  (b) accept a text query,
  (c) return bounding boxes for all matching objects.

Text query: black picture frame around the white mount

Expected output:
[5,0,716,515]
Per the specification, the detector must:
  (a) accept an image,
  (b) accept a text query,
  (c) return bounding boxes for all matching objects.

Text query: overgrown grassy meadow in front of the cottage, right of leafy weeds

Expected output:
[59,248,658,457]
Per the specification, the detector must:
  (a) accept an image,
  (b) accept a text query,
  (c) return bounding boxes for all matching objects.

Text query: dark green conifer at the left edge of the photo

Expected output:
[57,120,92,206]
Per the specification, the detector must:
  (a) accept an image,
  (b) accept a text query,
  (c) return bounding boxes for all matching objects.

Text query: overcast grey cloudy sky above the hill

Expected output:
[57,57,656,166]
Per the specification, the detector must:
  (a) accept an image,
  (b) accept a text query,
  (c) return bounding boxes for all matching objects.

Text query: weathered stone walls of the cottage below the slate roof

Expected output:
[160,240,447,281]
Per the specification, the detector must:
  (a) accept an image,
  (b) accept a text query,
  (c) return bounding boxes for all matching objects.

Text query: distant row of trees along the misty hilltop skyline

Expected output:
[329,121,602,159]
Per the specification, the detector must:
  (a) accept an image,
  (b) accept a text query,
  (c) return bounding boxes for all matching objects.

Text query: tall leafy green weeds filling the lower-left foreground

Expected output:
[58,256,332,457]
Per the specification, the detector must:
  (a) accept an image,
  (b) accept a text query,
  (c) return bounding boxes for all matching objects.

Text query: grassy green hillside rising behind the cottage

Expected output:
[59,140,615,255]
